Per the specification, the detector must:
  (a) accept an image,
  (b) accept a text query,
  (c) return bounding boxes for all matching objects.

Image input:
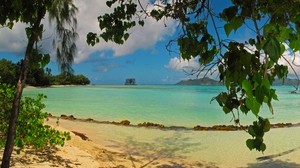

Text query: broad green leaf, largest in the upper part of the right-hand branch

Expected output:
[263,37,281,62]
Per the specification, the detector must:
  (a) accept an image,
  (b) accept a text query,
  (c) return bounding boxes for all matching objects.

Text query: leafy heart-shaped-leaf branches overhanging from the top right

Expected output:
[87,0,300,151]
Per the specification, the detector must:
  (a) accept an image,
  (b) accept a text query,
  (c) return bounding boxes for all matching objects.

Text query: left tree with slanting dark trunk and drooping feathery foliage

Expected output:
[0,0,77,168]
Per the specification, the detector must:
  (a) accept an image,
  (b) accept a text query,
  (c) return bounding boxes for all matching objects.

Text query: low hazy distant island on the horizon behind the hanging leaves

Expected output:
[177,77,299,87]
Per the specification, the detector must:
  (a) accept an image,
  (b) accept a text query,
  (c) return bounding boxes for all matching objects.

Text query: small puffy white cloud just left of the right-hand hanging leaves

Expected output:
[165,57,200,71]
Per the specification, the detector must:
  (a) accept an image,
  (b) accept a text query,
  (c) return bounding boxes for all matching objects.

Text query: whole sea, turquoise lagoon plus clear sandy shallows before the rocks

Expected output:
[24,85,300,168]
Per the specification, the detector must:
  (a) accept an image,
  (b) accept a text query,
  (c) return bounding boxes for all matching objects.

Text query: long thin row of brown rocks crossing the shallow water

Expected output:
[48,113,300,131]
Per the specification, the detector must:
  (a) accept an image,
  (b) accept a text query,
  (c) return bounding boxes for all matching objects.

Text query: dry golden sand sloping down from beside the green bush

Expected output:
[0,118,213,168]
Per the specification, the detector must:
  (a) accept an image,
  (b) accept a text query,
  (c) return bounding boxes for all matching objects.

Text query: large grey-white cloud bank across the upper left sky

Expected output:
[0,0,175,63]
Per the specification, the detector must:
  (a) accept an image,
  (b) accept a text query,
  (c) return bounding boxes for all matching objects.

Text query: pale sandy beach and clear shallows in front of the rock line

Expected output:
[1,118,300,168]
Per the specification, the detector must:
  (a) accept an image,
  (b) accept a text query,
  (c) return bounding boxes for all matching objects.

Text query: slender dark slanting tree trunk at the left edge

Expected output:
[1,7,46,168]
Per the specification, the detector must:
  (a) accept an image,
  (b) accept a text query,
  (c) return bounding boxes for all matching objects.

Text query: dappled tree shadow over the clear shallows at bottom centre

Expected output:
[102,132,218,168]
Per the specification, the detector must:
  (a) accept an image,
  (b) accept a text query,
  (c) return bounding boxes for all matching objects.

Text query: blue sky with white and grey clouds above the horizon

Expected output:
[0,0,300,84]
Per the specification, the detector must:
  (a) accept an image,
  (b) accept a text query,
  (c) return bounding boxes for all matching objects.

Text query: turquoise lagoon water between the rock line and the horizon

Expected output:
[24,85,300,127]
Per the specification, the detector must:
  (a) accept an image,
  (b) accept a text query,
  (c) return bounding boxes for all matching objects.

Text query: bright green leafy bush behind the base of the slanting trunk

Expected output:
[0,84,70,151]
